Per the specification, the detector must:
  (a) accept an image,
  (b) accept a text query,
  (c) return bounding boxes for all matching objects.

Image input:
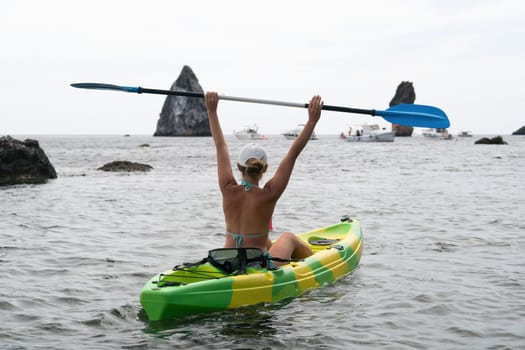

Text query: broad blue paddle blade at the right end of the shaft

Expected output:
[375,104,450,129]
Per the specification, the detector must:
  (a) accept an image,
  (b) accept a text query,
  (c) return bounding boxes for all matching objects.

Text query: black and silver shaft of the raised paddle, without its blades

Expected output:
[137,86,376,116]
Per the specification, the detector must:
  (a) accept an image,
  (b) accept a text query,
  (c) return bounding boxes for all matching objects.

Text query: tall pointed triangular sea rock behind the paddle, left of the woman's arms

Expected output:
[153,66,211,136]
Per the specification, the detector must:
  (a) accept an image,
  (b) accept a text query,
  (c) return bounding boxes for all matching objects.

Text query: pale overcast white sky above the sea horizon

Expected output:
[0,0,525,136]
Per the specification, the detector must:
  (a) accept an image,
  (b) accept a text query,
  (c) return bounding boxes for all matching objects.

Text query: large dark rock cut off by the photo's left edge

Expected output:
[0,136,57,186]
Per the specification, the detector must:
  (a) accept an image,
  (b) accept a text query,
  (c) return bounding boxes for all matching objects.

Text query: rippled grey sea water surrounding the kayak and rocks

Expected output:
[0,135,525,350]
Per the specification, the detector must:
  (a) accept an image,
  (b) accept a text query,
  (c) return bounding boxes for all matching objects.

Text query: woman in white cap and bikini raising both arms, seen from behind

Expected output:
[205,92,323,265]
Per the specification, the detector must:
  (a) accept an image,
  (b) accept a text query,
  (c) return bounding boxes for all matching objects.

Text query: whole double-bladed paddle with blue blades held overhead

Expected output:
[71,83,450,128]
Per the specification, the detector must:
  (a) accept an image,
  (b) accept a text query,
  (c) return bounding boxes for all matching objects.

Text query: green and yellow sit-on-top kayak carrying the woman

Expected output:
[140,217,363,321]
